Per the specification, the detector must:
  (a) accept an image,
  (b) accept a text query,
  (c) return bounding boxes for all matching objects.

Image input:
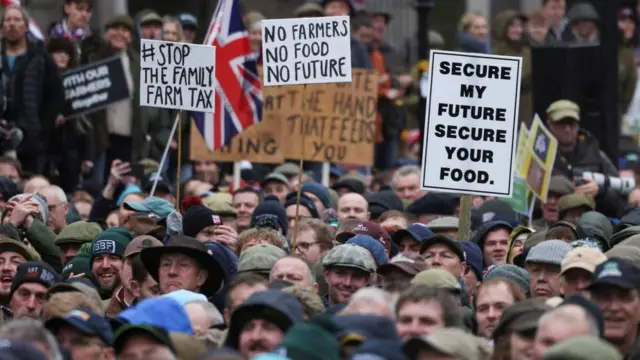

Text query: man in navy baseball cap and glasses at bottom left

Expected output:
[45,309,115,360]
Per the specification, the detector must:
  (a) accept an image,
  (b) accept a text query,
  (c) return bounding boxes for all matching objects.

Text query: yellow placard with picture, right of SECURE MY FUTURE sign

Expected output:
[520,115,558,202]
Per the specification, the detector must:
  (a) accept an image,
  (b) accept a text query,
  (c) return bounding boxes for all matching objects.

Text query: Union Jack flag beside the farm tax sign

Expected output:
[192,0,262,151]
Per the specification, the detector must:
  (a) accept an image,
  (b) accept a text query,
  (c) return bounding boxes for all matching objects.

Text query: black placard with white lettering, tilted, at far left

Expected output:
[61,56,131,118]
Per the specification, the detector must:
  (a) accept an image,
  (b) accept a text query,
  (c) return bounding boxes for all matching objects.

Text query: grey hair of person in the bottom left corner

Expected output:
[0,318,62,360]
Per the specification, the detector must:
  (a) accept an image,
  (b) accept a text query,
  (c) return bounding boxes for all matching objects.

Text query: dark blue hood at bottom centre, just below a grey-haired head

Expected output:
[334,315,401,342]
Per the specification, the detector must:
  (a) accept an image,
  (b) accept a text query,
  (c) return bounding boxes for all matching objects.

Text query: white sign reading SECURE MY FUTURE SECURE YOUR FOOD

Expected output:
[422,51,522,196]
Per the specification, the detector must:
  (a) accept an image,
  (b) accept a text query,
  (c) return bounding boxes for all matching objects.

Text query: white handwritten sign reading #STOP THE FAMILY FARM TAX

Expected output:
[140,39,216,113]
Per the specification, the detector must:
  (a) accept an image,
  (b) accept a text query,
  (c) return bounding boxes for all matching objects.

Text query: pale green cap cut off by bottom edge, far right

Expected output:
[542,335,622,360]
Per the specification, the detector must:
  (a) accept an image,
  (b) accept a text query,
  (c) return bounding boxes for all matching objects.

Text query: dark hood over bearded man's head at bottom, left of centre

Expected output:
[225,290,303,349]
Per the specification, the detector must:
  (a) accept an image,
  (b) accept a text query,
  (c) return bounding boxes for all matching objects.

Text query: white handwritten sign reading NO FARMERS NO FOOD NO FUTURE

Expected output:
[261,16,351,86]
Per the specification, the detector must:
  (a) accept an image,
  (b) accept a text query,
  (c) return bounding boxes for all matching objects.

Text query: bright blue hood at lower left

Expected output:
[116,297,193,335]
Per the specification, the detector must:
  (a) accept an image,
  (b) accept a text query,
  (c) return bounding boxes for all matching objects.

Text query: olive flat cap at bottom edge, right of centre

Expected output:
[404,328,492,360]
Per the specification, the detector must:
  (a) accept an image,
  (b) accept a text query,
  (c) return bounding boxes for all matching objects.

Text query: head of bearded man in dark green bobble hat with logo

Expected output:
[90,227,131,300]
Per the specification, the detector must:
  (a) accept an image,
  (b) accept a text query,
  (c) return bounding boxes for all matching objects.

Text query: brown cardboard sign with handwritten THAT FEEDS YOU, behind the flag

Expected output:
[191,69,378,166]
